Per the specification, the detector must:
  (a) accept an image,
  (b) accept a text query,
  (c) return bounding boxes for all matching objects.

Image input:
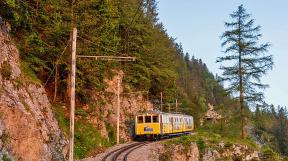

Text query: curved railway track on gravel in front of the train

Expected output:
[101,142,147,161]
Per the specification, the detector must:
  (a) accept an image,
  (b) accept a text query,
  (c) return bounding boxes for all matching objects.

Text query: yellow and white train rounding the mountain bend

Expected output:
[135,112,194,138]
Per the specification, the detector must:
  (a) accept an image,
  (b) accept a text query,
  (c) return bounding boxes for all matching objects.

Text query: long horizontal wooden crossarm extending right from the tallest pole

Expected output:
[77,55,136,61]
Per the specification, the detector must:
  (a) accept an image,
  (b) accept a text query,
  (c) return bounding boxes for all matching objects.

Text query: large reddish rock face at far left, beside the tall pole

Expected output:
[0,30,67,161]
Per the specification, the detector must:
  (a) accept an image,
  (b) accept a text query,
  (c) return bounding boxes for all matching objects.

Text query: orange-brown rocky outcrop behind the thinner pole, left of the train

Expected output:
[87,71,153,141]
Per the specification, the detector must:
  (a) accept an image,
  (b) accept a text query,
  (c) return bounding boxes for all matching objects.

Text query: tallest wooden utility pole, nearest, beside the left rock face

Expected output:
[69,28,77,161]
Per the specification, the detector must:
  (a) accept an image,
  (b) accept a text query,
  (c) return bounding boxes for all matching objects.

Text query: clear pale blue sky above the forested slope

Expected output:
[158,0,288,107]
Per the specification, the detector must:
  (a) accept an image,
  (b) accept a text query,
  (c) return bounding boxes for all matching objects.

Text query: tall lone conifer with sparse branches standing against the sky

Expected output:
[217,5,273,138]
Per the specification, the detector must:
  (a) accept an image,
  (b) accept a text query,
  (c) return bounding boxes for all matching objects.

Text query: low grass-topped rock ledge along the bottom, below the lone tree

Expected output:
[160,137,260,161]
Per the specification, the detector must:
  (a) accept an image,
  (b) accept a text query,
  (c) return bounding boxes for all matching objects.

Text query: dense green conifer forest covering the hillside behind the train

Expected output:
[0,0,288,159]
